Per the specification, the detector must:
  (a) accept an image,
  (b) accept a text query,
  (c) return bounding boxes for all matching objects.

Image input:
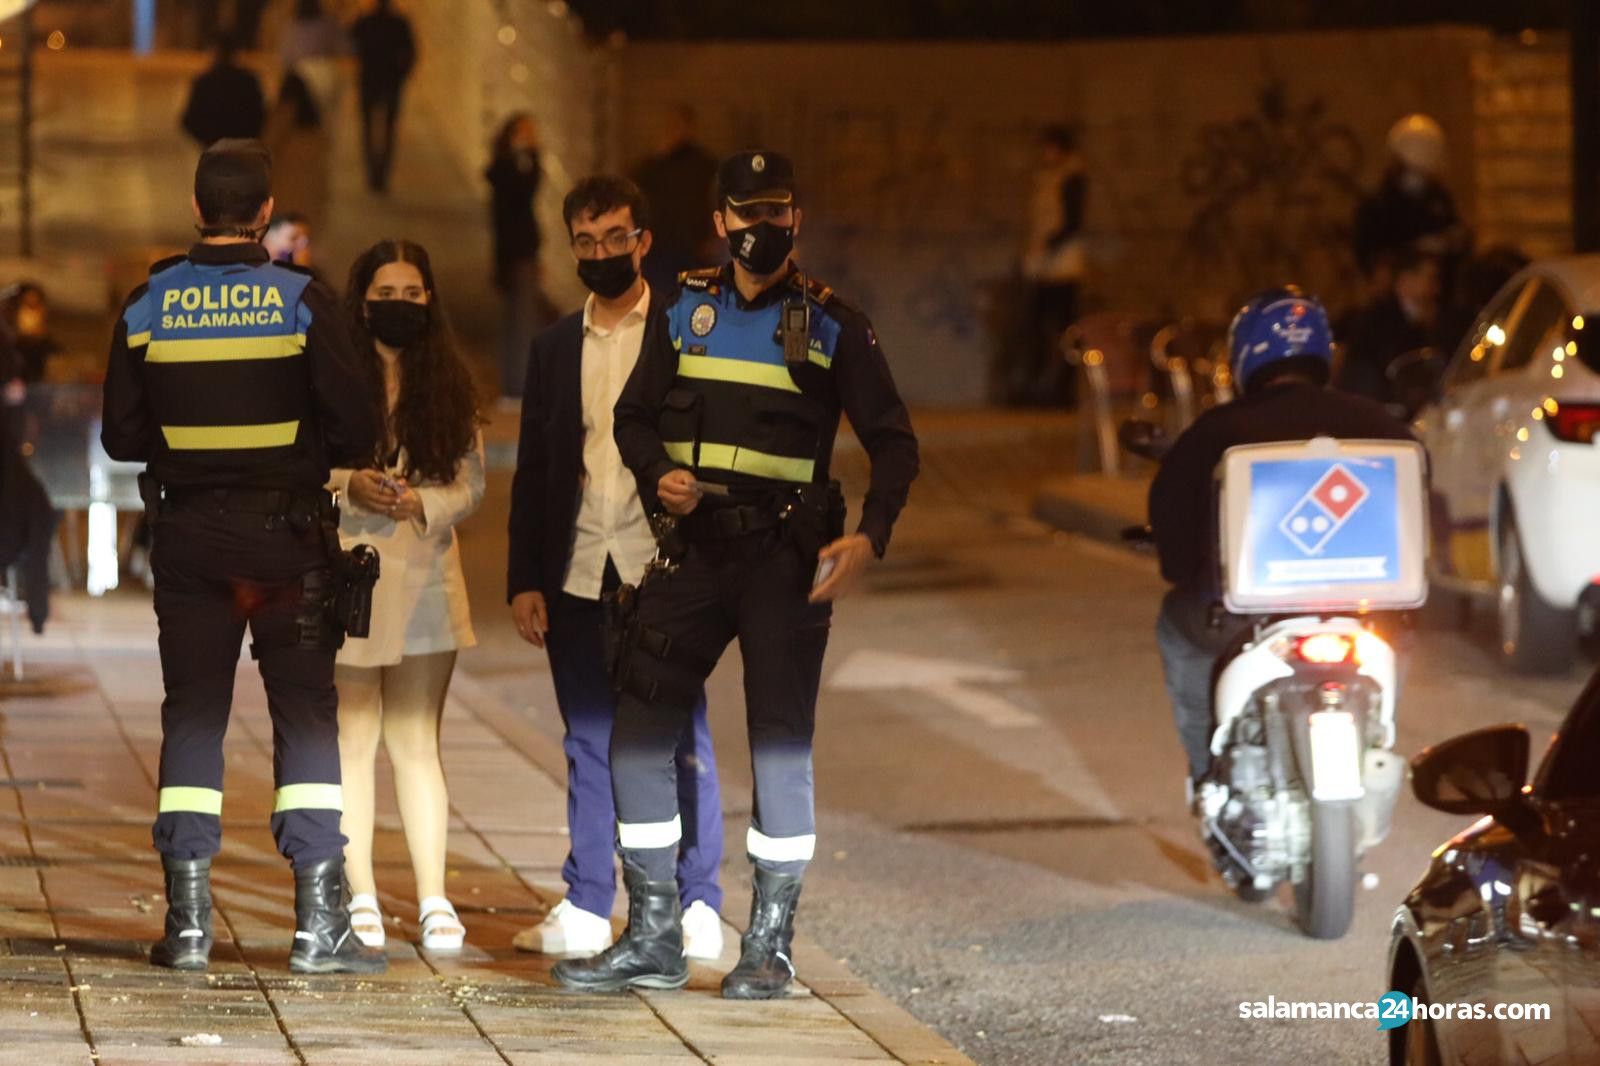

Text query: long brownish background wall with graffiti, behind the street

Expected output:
[621,27,1493,403]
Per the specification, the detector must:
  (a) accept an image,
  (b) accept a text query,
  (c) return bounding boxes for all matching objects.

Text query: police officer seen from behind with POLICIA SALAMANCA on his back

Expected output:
[101,141,386,973]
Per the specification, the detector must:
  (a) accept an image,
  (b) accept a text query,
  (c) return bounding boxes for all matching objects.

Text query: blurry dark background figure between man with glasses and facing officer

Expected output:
[634,104,720,293]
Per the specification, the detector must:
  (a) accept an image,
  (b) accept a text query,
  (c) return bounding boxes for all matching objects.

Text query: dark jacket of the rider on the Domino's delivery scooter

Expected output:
[1150,383,1413,597]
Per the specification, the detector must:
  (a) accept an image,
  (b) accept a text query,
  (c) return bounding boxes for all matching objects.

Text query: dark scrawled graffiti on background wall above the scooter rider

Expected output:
[1179,78,1363,305]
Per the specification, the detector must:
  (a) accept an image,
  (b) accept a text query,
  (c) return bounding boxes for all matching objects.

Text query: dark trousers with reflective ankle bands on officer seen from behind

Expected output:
[150,503,344,868]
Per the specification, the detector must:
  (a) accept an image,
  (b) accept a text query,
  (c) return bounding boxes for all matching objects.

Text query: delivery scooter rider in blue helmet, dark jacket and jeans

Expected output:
[1149,285,1413,795]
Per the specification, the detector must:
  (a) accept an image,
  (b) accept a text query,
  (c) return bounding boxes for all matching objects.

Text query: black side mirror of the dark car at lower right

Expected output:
[1411,725,1530,813]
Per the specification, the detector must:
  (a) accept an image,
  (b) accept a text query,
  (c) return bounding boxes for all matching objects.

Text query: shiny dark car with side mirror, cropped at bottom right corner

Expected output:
[1389,675,1600,1066]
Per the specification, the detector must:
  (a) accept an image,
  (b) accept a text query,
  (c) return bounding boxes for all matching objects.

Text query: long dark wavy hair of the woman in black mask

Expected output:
[344,240,482,482]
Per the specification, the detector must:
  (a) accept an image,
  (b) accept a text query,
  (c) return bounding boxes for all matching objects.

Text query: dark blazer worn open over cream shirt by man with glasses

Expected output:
[506,301,588,602]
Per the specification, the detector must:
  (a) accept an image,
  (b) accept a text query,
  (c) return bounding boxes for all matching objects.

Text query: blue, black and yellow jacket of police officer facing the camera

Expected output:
[614,264,918,555]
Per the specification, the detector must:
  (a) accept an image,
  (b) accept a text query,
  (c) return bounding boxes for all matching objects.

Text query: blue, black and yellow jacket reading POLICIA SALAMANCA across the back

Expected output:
[101,242,378,491]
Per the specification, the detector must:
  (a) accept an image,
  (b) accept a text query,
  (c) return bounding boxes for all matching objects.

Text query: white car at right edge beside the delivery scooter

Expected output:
[1416,256,1600,672]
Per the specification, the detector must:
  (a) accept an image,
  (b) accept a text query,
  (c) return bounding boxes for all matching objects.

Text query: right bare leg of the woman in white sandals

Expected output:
[384,651,456,900]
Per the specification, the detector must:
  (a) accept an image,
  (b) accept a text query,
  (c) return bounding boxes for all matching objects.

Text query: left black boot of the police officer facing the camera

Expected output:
[550,866,690,992]
